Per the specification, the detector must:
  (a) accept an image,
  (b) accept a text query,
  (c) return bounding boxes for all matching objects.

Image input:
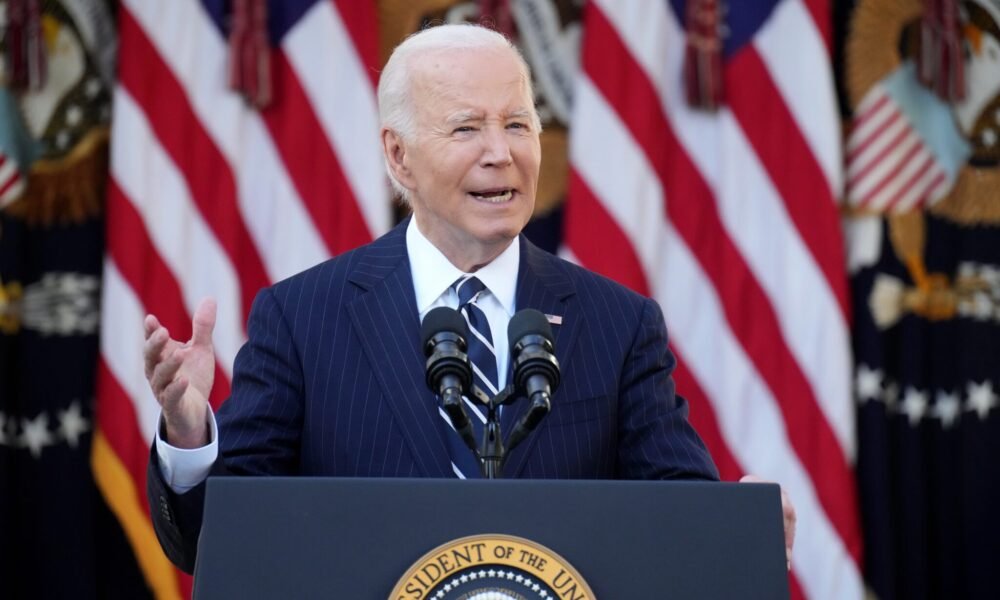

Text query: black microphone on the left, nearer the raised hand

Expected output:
[420,306,479,458]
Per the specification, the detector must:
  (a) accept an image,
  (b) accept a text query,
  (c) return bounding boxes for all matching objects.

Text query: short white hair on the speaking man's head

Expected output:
[378,23,542,203]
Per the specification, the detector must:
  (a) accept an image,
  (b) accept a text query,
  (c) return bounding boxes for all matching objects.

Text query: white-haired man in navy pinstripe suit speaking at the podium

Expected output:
[144,25,794,571]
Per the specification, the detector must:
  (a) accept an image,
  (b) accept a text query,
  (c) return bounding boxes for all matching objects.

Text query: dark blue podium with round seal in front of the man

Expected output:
[194,477,788,600]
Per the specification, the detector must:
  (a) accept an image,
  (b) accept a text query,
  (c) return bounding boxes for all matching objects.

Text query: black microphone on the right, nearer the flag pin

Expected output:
[507,308,559,450]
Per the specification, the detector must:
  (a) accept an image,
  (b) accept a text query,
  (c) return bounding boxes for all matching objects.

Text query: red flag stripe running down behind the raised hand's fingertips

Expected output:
[105,177,229,406]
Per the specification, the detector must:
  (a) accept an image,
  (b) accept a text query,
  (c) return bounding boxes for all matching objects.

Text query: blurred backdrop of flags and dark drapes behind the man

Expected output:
[0,0,1000,600]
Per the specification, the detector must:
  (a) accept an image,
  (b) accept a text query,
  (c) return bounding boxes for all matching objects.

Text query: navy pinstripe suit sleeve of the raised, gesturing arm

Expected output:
[146,288,303,573]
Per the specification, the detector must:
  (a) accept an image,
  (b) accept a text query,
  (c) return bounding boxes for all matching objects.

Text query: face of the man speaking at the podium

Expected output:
[392,49,541,270]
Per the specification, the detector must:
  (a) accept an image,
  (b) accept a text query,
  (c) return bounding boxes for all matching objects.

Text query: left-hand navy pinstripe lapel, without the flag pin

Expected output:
[347,219,452,477]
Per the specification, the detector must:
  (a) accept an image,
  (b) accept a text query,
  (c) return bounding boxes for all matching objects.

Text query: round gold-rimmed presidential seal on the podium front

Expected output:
[389,534,594,600]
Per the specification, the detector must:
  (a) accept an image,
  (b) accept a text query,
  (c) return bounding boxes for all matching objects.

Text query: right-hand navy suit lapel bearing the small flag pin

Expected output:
[503,236,583,478]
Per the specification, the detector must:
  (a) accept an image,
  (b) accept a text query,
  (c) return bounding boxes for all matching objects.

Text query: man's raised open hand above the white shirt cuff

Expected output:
[142,298,216,448]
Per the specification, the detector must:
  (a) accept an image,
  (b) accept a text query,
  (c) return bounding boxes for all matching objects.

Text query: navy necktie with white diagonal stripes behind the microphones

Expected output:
[445,275,499,479]
